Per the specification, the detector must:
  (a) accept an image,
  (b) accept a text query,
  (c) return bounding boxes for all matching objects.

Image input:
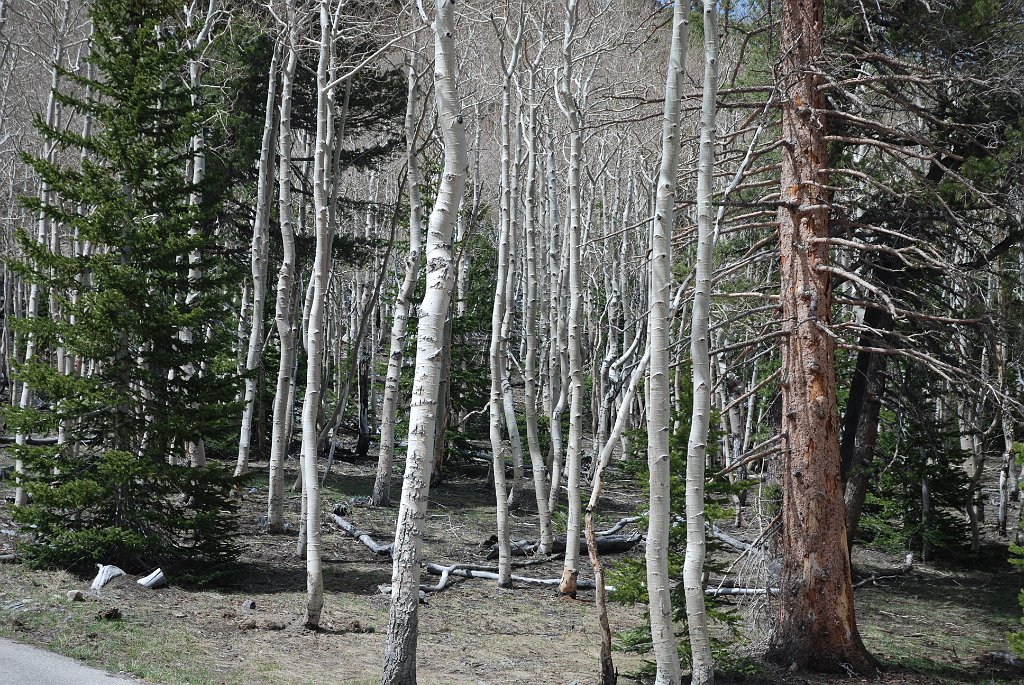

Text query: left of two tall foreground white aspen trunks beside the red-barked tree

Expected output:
[646,0,703,685]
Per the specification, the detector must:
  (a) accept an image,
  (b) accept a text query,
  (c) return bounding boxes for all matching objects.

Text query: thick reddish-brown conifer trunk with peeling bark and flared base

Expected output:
[767,0,877,673]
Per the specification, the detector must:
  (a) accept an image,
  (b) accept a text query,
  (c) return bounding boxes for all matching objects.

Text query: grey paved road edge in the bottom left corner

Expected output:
[0,639,143,685]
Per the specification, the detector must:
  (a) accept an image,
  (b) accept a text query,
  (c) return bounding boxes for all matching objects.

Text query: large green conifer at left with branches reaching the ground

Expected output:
[8,0,238,573]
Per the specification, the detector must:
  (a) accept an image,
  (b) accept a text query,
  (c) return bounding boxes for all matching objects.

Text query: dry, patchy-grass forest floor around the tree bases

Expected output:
[0,448,1024,685]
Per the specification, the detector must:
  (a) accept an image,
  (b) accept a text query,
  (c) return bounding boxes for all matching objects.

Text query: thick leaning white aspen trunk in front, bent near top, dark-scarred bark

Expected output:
[381,0,469,685]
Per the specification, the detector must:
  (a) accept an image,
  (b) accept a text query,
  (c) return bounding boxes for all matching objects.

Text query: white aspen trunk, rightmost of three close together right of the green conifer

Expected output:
[302,0,334,629]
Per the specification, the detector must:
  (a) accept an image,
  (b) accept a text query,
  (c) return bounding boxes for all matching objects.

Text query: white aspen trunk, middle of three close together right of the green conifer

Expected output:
[266,0,299,533]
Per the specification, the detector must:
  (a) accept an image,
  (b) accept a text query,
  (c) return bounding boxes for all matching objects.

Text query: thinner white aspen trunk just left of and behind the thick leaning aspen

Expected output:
[371,34,423,507]
